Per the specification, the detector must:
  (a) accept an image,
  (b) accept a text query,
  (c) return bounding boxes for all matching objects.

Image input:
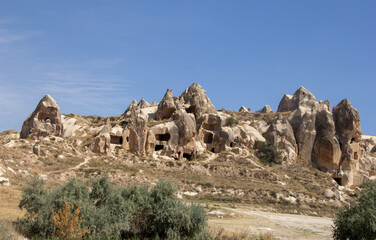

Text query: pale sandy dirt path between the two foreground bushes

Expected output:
[209,208,333,239]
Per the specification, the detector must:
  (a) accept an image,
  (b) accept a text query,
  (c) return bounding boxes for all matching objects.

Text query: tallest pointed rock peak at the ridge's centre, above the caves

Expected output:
[179,83,217,119]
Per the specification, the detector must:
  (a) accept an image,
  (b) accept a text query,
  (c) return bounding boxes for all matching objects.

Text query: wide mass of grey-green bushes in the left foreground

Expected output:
[19,176,207,239]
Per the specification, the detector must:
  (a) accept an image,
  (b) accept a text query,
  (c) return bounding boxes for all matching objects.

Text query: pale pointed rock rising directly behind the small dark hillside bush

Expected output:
[263,115,298,161]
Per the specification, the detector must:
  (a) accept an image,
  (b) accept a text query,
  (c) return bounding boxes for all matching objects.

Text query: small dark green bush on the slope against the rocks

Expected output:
[254,141,282,165]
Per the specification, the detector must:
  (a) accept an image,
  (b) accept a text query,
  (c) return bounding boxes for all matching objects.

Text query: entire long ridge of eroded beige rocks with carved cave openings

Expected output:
[13,83,376,186]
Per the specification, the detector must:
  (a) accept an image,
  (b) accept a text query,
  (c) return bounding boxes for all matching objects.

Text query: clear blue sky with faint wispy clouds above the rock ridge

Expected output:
[0,0,376,135]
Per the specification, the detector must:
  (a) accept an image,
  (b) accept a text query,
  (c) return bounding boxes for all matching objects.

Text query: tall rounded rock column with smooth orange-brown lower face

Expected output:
[312,108,341,171]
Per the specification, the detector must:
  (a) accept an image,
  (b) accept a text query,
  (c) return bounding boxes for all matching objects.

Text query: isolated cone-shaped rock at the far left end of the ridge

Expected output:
[20,94,63,139]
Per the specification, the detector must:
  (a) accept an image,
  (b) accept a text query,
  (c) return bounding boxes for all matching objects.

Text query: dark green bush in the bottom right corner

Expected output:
[333,183,376,240]
